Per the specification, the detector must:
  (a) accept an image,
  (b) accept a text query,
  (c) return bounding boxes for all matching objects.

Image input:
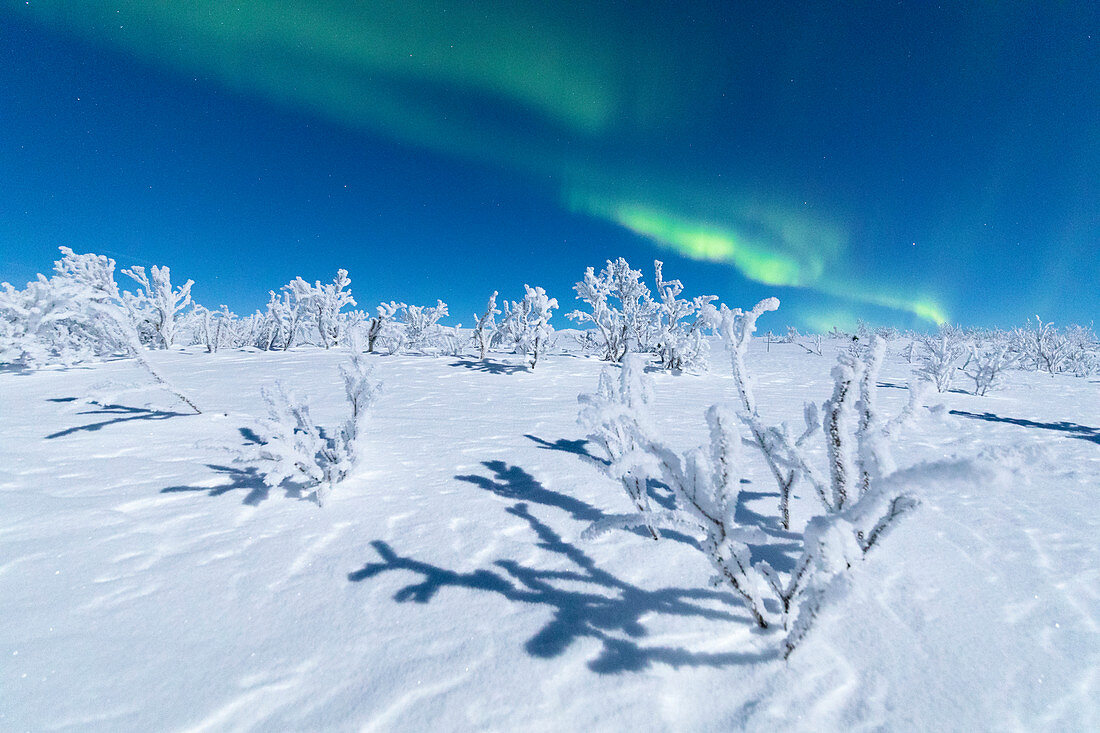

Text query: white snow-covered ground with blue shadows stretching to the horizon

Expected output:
[0,343,1100,731]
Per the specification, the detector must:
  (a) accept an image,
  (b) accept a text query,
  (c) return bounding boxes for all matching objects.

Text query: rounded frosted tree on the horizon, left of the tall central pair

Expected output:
[567,258,653,361]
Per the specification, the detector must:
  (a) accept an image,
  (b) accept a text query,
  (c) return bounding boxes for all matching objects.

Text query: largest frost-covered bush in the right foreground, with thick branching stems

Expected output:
[580,298,937,654]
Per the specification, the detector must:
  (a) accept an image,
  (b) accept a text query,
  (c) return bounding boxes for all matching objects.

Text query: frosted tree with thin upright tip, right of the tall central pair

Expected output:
[652,260,718,370]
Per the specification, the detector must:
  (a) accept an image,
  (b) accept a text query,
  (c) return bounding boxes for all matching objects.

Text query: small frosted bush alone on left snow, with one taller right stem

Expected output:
[239,337,382,505]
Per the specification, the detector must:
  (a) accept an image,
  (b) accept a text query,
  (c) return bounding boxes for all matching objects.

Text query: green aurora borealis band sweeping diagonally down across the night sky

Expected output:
[8,0,1095,324]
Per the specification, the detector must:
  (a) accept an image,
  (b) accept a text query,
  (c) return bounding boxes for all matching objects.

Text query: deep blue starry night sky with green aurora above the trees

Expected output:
[0,0,1100,330]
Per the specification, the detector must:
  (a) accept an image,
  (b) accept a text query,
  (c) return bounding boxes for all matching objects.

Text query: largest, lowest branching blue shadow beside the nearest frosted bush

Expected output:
[348,499,777,674]
